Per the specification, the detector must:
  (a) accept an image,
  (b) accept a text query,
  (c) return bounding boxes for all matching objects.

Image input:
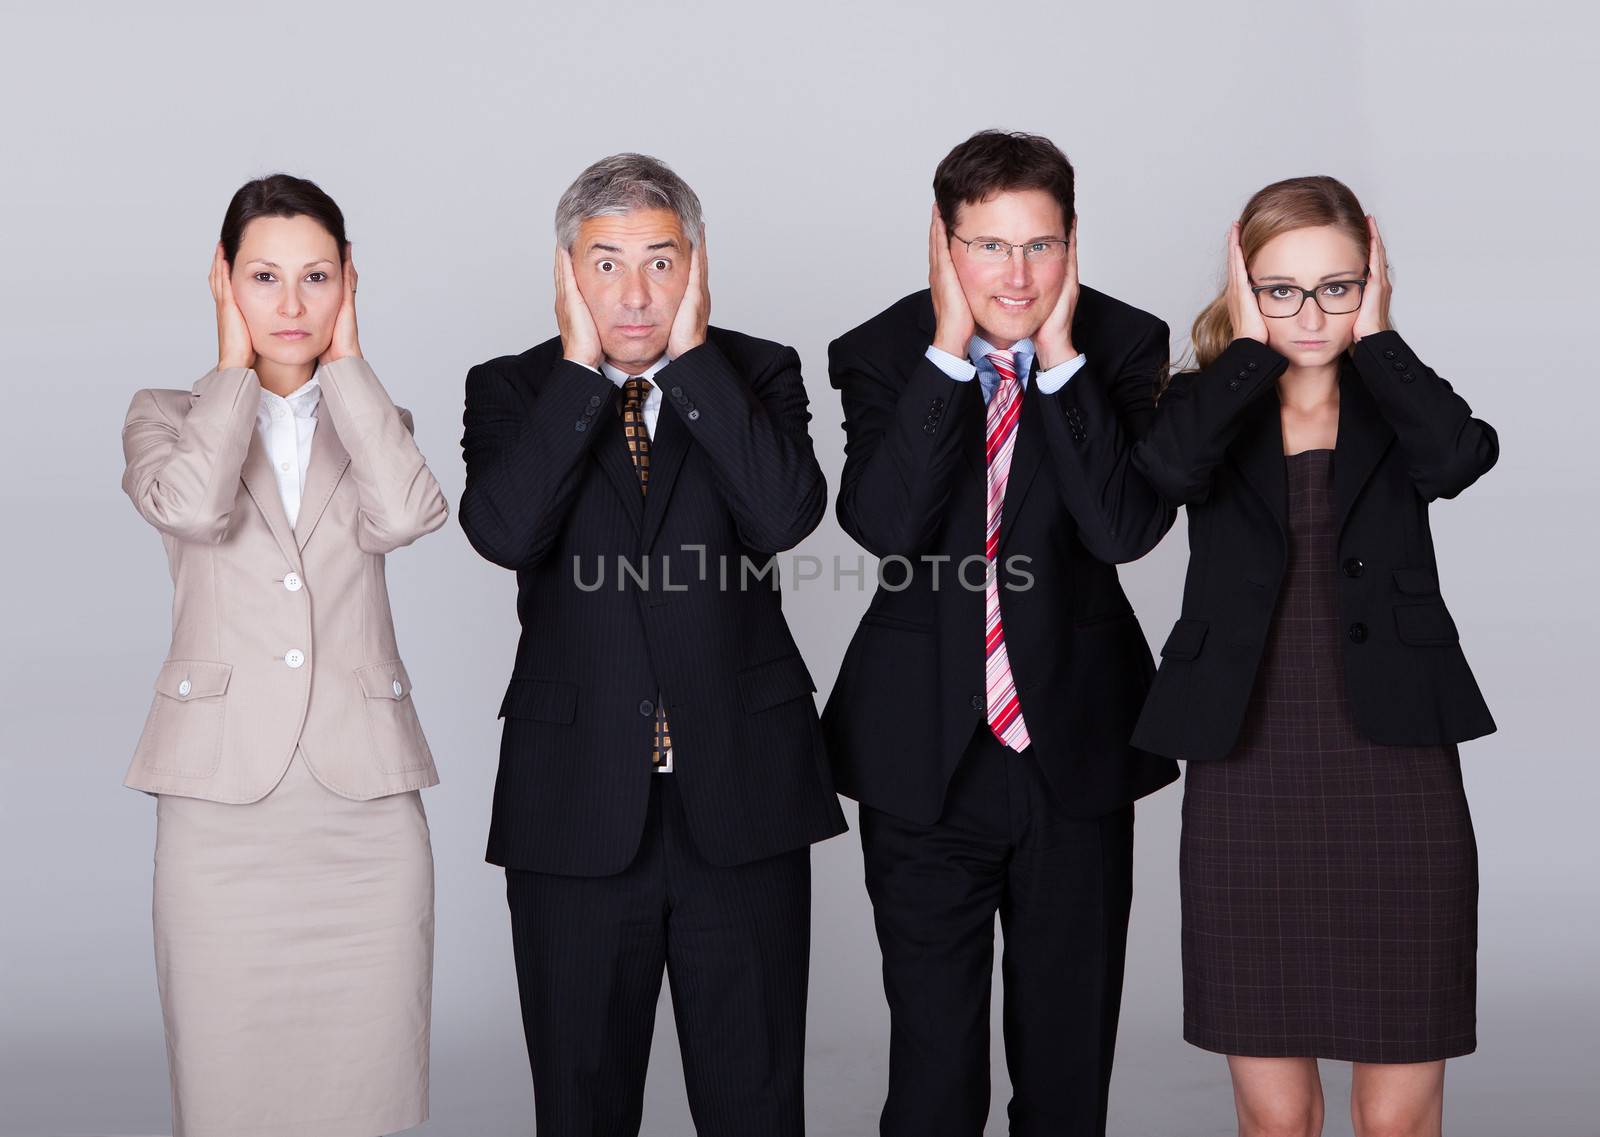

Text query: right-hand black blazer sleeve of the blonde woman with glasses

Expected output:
[1354,331,1499,501]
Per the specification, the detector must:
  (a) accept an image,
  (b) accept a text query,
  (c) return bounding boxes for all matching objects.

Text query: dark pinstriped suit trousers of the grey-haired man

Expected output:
[506,774,811,1137]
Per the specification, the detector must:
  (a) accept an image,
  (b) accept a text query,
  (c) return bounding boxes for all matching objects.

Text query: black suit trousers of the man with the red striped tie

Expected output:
[861,726,1133,1137]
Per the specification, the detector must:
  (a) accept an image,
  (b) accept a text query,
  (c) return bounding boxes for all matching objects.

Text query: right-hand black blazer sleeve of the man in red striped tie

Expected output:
[1038,320,1178,565]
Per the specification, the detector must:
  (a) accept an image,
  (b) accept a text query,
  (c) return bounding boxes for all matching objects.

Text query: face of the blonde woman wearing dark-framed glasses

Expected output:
[1248,225,1366,368]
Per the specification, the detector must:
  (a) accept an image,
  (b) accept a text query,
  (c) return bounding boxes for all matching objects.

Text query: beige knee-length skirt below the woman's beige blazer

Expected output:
[154,752,434,1137]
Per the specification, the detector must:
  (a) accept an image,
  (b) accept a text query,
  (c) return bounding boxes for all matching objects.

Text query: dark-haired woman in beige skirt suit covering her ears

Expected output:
[122,174,446,1137]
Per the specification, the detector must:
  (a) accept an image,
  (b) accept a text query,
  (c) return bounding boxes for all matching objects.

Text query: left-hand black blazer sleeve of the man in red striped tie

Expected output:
[827,341,981,557]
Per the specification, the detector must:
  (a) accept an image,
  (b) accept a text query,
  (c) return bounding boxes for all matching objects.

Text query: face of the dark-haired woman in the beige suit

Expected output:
[232,216,344,366]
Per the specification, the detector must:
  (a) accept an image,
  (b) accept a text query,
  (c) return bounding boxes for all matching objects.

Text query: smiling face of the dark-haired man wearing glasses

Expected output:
[950,190,1067,349]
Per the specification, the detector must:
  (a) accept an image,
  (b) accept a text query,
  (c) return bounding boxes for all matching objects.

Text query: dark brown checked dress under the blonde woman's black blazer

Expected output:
[1179,449,1478,1062]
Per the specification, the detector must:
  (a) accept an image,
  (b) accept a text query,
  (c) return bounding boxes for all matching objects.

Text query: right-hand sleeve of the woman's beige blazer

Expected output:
[318,355,450,553]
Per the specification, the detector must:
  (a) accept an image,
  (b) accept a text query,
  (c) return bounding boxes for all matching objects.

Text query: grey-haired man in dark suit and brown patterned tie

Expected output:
[461,154,845,1137]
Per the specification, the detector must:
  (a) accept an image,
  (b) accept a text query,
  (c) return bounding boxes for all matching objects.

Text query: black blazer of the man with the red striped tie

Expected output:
[822,288,1178,824]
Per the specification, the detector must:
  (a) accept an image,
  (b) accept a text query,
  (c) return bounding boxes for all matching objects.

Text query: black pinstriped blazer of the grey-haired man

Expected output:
[461,328,845,876]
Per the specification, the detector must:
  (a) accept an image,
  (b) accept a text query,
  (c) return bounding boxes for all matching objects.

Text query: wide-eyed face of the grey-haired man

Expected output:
[573,209,690,373]
